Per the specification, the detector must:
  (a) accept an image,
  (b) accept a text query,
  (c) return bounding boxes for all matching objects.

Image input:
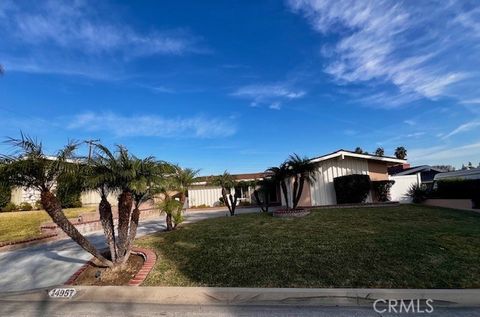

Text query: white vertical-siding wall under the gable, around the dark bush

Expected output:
[310,157,371,206]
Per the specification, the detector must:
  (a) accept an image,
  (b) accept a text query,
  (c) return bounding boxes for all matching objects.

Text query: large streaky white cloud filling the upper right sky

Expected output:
[288,0,480,106]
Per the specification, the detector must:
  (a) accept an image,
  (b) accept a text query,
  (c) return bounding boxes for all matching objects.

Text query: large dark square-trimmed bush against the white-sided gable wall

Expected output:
[333,174,370,204]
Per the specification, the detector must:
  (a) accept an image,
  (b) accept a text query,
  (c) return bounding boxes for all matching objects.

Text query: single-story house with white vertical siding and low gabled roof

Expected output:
[188,150,406,207]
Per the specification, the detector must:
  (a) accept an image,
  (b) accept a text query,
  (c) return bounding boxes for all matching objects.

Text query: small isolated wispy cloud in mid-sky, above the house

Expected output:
[231,83,306,110]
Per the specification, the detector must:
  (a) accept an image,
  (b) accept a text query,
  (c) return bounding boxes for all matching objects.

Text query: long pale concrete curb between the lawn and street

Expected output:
[0,286,480,308]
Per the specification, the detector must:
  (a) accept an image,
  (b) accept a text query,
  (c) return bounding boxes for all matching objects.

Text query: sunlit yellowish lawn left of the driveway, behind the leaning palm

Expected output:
[0,207,95,242]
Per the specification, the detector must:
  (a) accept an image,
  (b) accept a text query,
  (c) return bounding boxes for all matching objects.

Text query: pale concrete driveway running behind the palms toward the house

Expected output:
[0,208,259,292]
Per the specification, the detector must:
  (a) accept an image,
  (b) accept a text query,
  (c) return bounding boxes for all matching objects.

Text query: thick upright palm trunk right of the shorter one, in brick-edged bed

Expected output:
[117,190,133,263]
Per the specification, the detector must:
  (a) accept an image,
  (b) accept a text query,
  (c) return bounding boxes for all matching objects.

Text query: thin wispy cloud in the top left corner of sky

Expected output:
[0,0,198,56]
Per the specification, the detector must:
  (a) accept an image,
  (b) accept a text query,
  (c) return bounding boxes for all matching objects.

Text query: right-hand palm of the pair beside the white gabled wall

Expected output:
[287,153,317,209]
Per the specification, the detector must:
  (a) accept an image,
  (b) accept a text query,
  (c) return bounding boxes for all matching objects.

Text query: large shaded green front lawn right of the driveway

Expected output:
[137,205,480,288]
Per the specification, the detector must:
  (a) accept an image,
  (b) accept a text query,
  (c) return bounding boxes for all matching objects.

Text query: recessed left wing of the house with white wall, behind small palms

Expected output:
[188,173,280,208]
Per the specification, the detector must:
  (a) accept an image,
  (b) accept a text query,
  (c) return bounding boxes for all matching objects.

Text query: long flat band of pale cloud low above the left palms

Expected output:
[67,112,236,138]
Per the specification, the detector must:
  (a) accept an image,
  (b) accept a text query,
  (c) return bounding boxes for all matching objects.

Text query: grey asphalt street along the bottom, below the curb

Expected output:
[0,300,480,317]
